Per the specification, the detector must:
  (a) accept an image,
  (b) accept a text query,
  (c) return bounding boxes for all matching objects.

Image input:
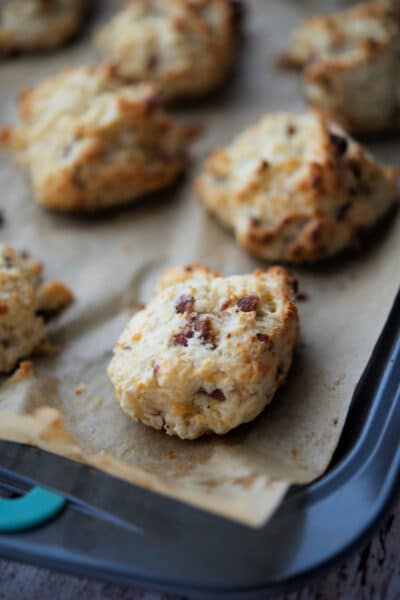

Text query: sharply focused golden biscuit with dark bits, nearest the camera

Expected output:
[108,265,298,439]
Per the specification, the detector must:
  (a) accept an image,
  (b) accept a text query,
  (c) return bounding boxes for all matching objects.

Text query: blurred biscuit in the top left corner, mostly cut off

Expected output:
[0,0,87,55]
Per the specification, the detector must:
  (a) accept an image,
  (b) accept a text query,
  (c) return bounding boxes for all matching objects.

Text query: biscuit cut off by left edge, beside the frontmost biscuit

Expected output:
[0,244,73,373]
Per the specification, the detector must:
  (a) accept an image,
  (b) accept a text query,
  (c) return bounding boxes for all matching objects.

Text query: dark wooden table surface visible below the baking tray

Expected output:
[0,499,400,600]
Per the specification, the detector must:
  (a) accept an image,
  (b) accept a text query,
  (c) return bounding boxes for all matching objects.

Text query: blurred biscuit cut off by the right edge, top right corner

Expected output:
[280,2,400,132]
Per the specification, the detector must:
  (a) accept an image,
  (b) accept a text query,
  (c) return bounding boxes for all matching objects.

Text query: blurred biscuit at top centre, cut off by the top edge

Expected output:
[94,0,239,98]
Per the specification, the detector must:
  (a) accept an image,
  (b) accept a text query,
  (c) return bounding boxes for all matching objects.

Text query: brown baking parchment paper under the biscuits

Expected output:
[0,0,400,526]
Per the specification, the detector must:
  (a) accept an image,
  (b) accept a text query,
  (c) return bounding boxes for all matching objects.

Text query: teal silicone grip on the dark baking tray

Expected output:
[0,487,66,532]
